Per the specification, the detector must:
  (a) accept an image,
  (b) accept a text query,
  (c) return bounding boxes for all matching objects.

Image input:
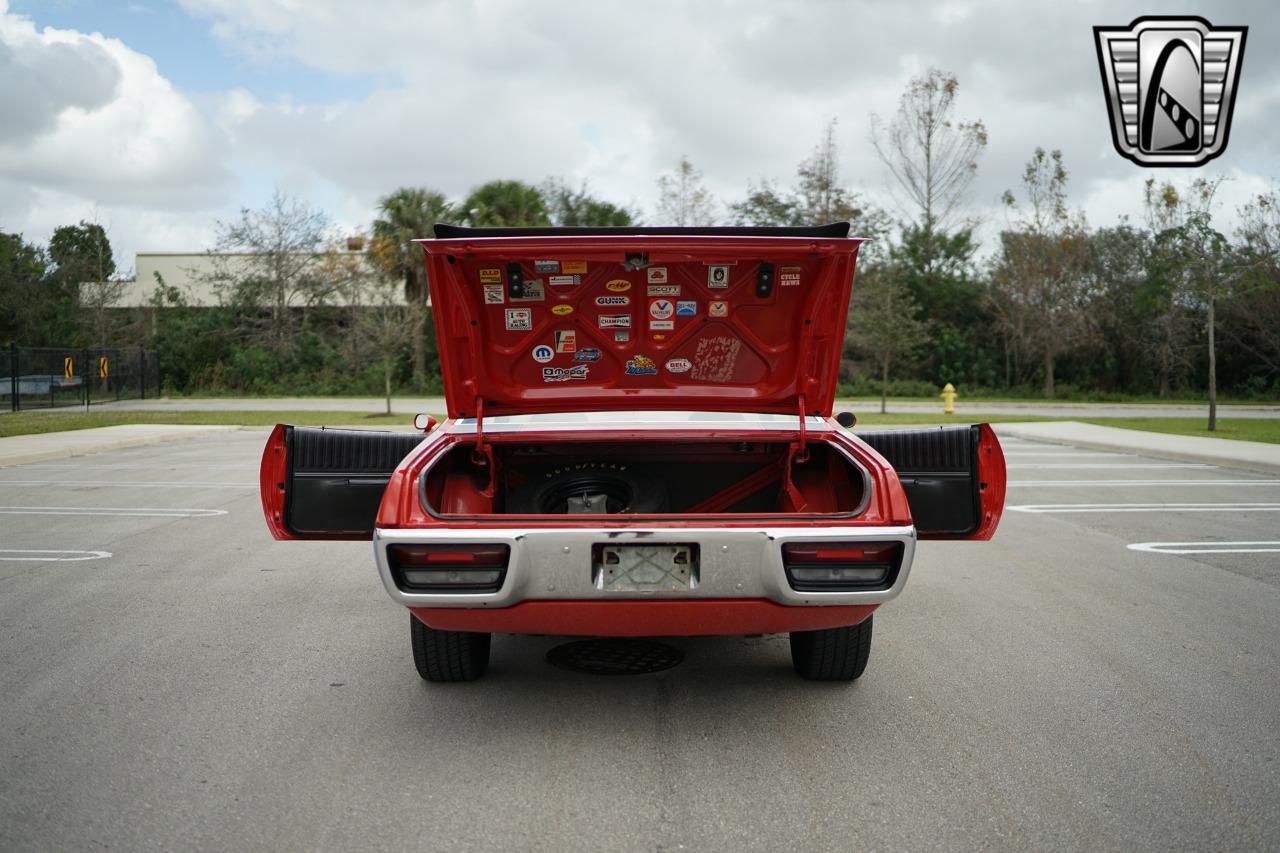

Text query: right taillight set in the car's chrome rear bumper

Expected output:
[782,542,902,592]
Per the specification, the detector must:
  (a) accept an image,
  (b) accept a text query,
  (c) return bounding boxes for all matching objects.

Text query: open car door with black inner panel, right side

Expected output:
[858,424,1005,539]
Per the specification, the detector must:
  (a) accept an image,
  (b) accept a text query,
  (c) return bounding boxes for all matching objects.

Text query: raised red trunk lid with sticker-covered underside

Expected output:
[419,223,863,418]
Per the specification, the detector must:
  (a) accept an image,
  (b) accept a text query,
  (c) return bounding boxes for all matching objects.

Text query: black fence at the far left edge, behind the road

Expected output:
[0,345,160,411]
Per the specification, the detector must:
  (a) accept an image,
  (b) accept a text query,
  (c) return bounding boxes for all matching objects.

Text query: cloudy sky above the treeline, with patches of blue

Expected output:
[0,0,1280,269]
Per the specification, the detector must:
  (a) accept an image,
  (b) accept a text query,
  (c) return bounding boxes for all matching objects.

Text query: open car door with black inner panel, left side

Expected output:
[259,424,422,539]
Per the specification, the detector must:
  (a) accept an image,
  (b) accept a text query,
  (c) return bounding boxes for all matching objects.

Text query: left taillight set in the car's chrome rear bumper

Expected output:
[387,543,511,593]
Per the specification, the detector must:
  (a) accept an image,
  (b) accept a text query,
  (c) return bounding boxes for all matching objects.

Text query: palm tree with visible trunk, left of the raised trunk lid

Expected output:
[369,187,457,387]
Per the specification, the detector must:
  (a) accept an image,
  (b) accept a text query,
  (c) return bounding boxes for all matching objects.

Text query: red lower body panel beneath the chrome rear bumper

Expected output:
[410,598,879,637]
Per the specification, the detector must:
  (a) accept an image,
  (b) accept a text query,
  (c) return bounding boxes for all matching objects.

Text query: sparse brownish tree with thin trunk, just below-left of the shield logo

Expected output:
[991,149,1088,397]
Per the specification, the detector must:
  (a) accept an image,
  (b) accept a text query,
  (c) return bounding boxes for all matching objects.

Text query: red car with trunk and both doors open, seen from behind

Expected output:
[261,224,1005,681]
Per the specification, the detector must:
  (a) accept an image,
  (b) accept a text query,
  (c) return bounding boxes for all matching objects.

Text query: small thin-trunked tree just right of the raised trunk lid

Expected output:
[847,265,929,414]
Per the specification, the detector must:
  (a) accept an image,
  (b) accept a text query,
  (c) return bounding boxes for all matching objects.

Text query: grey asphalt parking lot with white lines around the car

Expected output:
[0,430,1280,850]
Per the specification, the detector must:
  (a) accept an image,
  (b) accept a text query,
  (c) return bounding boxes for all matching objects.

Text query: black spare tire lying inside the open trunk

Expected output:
[507,462,667,515]
